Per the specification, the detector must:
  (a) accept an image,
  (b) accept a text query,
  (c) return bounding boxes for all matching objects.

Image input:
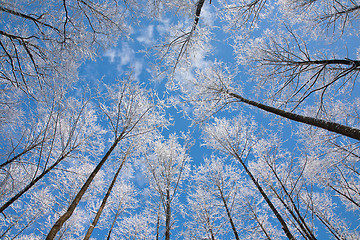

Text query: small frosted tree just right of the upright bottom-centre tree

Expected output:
[189,156,247,240]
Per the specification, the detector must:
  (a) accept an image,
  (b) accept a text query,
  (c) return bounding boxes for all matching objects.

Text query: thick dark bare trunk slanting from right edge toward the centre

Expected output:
[228,92,360,140]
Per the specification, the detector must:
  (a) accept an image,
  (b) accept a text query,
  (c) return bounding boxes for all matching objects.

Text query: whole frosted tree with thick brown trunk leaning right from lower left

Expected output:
[46,75,166,239]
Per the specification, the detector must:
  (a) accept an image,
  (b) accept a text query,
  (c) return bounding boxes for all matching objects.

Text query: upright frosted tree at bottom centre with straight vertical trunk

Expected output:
[145,135,191,240]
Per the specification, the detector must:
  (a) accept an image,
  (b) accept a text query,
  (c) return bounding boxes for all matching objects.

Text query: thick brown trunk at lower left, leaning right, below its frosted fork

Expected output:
[46,132,124,240]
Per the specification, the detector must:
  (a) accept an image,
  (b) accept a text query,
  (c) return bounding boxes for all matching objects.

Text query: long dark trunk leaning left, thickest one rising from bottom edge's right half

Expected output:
[233,153,295,240]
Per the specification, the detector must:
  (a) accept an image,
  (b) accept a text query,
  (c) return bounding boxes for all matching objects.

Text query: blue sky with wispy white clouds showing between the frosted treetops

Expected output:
[0,1,360,239]
